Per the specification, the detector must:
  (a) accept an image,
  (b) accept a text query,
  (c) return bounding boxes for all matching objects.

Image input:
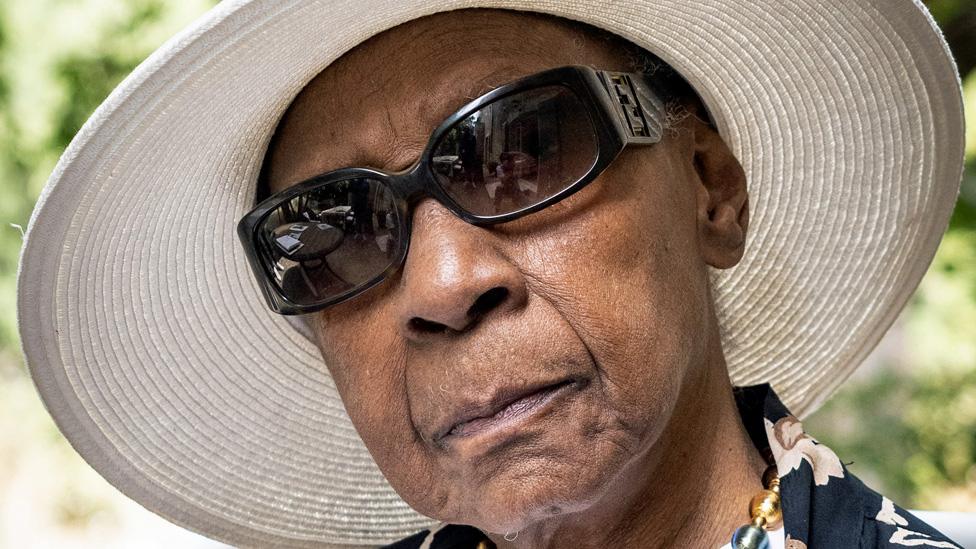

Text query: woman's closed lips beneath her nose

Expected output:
[434,379,580,442]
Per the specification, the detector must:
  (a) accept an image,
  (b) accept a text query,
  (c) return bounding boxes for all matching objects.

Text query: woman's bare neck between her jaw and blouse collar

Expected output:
[492,332,765,549]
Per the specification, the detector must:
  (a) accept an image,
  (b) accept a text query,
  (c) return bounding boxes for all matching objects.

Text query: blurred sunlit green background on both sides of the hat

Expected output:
[0,0,976,549]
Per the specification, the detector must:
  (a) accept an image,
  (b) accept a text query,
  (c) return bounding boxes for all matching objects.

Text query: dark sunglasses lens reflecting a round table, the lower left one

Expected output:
[259,178,403,305]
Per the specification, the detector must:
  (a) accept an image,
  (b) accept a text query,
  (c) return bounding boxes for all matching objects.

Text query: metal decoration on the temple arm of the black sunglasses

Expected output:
[598,71,664,144]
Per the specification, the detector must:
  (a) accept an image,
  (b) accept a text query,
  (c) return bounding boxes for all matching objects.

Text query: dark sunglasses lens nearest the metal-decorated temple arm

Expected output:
[431,86,599,216]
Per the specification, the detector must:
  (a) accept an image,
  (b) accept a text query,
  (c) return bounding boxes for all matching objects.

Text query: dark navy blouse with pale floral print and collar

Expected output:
[387,385,962,549]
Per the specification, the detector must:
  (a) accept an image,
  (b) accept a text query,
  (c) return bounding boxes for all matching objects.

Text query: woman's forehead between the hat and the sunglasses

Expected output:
[266,9,627,192]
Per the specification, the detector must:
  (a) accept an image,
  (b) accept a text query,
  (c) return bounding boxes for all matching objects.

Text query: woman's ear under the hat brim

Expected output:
[690,117,749,269]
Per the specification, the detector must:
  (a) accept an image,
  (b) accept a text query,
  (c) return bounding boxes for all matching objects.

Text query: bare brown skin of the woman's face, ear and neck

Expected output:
[267,10,764,548]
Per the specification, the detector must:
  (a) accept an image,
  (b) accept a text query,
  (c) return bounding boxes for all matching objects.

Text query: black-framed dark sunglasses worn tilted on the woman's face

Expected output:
[237,67,668,315]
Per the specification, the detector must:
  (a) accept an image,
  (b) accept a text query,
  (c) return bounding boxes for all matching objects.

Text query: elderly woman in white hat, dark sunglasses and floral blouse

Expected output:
[20,0,962,548]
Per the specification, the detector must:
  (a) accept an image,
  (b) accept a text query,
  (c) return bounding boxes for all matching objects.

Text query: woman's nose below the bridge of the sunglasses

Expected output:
[399,199,527,341]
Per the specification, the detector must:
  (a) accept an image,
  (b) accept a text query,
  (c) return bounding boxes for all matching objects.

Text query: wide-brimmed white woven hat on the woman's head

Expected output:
[18,0,964,547]
